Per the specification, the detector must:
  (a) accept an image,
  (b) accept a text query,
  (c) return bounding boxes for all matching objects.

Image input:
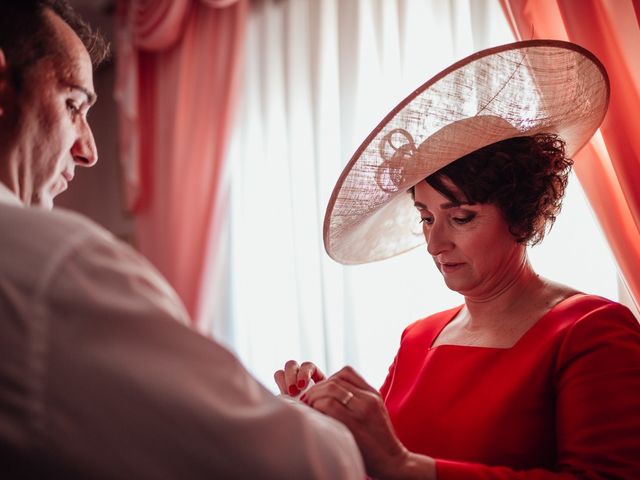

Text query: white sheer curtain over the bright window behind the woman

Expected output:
[208,0,616,389]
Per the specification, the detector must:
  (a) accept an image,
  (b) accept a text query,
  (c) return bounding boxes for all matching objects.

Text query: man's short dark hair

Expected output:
[0,0,109,89]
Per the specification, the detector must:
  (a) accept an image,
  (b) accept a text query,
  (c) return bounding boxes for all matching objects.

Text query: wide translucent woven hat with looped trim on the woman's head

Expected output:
[323,40,609,264]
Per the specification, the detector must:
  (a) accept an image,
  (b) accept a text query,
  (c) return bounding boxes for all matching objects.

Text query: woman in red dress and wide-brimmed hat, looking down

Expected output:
[275,41,640,479]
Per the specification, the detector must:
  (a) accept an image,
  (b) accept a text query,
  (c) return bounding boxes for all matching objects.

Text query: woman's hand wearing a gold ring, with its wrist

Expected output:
[301,367,435,478]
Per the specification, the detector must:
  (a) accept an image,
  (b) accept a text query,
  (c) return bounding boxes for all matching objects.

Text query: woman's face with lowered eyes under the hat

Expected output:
[414,181,526,300]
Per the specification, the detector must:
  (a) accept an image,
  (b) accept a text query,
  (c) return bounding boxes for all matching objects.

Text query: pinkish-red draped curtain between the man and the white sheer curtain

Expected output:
[115,0,248,323]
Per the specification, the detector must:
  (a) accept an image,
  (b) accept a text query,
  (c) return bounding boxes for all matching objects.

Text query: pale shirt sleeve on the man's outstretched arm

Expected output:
[34,231,364,479]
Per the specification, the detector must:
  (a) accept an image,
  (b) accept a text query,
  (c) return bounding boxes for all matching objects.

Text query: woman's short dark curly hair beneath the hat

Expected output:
[426,133,573,245]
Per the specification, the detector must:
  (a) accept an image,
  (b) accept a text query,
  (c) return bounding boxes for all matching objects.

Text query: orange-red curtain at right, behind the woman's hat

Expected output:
[501,0,640,305]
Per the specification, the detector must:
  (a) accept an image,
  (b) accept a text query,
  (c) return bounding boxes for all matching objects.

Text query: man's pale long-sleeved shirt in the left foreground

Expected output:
[0,183,364,480]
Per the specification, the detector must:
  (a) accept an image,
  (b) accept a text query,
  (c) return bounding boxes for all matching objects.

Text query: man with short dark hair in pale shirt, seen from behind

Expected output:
[0,0,364,479]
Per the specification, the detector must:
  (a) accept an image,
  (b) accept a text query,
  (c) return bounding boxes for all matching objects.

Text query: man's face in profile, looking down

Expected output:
[5,12,98,208]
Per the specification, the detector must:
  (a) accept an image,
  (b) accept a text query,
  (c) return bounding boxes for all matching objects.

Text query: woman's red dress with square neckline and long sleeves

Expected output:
[380,294,640,480]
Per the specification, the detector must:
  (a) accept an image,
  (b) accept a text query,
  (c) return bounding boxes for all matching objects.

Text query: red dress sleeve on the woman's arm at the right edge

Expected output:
[436,303,640,480]
